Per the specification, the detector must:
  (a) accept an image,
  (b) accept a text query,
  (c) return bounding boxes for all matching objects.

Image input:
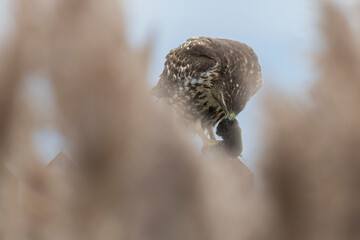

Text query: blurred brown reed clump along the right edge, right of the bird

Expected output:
[265,3,360,239]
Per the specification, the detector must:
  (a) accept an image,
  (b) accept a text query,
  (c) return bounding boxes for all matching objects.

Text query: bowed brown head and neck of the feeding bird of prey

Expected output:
[213,39,262,120]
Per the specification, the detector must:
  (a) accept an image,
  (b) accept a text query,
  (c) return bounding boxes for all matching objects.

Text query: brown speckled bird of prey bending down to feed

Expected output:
[153,37,262,146]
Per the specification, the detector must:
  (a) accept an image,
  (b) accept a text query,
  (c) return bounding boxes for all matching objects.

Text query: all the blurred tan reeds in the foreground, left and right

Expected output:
[0,0,360,240]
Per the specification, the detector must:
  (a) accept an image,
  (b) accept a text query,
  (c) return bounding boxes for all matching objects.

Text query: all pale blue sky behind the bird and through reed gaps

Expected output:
[0,0,330,168]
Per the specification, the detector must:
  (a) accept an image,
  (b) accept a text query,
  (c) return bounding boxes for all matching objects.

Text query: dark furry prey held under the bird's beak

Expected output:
[216,118,243,157]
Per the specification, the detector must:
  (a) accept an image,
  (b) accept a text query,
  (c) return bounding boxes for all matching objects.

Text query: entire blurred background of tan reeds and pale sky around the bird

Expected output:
[0,0,360,240]
